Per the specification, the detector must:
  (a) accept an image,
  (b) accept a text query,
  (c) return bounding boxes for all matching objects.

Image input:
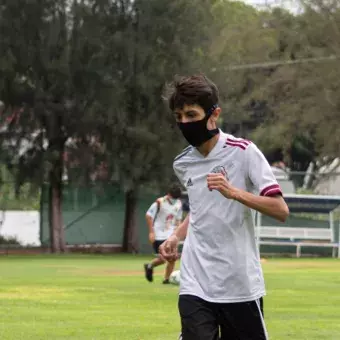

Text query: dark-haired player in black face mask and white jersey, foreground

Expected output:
[160,76,289,340]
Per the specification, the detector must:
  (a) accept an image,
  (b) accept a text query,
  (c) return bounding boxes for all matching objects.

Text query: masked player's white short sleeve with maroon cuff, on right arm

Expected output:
[246,144,282,196]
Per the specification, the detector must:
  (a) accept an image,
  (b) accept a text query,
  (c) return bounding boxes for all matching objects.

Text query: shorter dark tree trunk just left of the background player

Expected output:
[122,188,139,253]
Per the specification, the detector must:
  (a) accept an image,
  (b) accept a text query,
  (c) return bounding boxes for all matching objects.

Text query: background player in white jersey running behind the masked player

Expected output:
[144,185,182,284]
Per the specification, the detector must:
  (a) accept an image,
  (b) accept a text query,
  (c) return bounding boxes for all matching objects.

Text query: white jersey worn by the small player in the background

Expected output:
[147,196,183,241]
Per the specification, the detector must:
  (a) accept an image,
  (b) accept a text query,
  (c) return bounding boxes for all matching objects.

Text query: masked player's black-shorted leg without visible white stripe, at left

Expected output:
[178,295,219,340]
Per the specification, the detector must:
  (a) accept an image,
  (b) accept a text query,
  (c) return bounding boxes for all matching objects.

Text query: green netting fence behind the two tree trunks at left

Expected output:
[41,184,155,252]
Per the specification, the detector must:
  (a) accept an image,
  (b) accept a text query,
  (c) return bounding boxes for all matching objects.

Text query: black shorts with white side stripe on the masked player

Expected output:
[178,295,268,340]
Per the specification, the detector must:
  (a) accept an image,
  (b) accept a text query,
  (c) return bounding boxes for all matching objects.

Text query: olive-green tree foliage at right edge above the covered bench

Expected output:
[247,1,340,185]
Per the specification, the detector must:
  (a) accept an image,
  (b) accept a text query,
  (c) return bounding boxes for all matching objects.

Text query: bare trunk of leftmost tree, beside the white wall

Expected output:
[49,141,66,253]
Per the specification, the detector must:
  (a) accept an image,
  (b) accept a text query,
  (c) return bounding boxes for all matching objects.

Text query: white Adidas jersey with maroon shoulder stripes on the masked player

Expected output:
[174,131,281,303]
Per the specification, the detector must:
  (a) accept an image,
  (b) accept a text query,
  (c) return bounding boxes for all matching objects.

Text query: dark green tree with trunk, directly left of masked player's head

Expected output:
[93,0,219,252]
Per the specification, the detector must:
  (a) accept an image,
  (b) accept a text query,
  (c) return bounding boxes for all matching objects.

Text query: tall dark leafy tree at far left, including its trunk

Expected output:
[0,0,111,252]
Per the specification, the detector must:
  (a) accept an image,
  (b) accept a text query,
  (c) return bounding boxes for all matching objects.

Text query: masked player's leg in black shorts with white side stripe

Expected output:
[219,299,268,340]
